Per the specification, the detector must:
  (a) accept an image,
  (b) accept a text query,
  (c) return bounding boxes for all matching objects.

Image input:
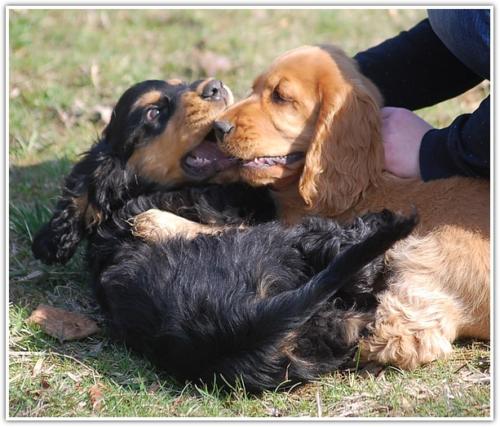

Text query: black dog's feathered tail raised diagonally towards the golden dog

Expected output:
[203,212,418,391]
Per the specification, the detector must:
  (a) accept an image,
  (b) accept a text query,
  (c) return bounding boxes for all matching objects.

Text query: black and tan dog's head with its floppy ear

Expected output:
[33,79,240,264]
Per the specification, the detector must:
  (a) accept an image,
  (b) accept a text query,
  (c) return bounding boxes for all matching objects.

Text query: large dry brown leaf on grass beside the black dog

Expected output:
[27,304,99,341]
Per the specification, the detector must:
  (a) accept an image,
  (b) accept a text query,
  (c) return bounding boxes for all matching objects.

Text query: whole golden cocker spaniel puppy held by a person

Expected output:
[218,46,490,368]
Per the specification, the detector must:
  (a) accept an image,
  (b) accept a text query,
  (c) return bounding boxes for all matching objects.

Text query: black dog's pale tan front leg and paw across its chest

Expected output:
[131,209,225,242]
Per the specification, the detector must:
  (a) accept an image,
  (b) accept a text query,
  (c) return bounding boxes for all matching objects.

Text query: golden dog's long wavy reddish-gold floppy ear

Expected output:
[299,72,384,215]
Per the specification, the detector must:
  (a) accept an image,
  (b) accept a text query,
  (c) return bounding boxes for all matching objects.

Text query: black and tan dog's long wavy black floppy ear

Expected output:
[32,140,126,264]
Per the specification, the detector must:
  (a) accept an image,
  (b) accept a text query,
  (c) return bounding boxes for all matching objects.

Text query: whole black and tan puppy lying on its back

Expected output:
[33,81,415,391]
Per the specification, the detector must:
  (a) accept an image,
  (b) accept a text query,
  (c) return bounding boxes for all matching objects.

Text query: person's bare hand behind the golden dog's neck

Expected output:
[381,107,432,178]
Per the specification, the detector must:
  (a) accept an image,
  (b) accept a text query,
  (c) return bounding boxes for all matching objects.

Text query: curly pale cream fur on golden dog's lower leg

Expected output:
[360,275,462,369]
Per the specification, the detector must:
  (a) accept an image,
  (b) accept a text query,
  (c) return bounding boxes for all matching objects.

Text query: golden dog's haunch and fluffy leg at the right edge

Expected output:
[360,227,489,369]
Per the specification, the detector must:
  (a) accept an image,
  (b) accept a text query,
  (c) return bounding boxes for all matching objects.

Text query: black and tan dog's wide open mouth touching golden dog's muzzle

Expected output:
[181,131,239,180]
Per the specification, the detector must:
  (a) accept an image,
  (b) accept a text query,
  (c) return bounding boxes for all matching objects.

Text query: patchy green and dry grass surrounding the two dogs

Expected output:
[8,9,491,417]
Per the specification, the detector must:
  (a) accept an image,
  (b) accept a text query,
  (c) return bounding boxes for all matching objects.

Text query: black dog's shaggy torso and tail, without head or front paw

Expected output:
[88,204,415,392]
